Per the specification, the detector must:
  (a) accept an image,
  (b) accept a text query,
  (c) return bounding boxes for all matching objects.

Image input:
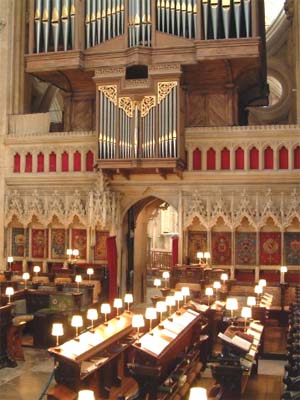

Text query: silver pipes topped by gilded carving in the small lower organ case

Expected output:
[98,81,178,159]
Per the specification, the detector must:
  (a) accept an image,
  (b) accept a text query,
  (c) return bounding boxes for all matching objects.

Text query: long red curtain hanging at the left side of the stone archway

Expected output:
[106,236,118,303]
